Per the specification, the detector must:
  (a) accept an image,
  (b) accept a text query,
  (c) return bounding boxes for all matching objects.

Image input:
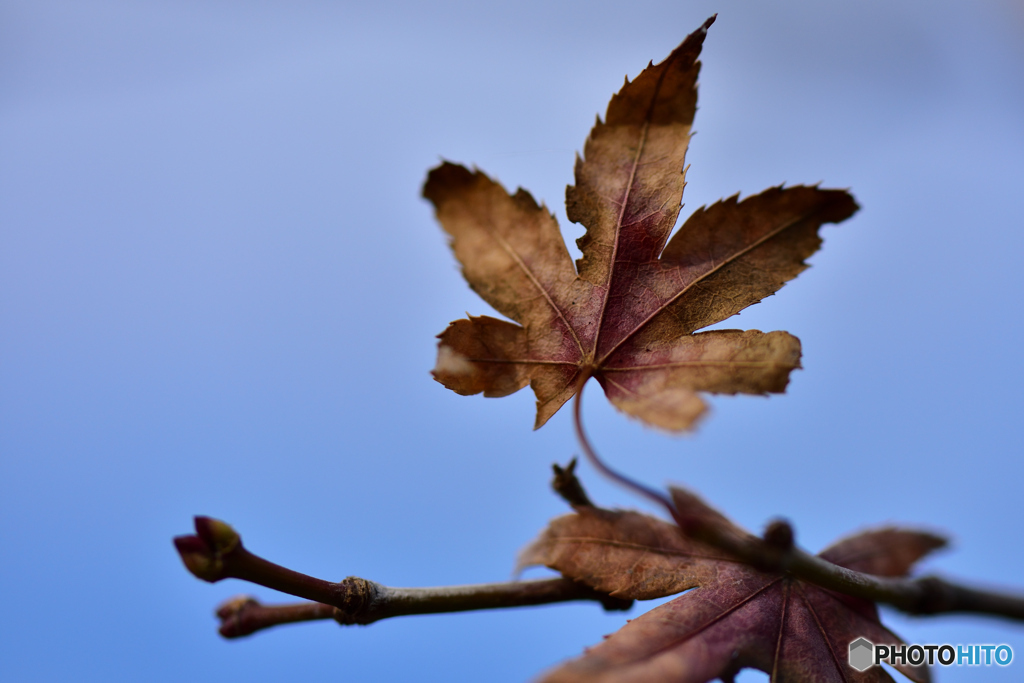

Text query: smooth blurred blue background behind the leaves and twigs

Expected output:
[0,0,1024,682]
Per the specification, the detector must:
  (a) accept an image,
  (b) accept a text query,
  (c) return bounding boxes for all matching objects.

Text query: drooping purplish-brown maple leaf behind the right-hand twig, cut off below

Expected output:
[520,489,945,683]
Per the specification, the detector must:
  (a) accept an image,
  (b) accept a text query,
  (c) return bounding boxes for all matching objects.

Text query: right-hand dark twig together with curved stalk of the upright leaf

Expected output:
[573,386,1024,621]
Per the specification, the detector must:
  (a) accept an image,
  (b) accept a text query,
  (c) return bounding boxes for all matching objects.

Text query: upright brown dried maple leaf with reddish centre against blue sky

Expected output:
[423,17,857,430]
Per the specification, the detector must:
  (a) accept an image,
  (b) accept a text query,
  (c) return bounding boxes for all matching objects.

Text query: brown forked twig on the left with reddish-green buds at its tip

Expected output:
[174,517,633,637]
